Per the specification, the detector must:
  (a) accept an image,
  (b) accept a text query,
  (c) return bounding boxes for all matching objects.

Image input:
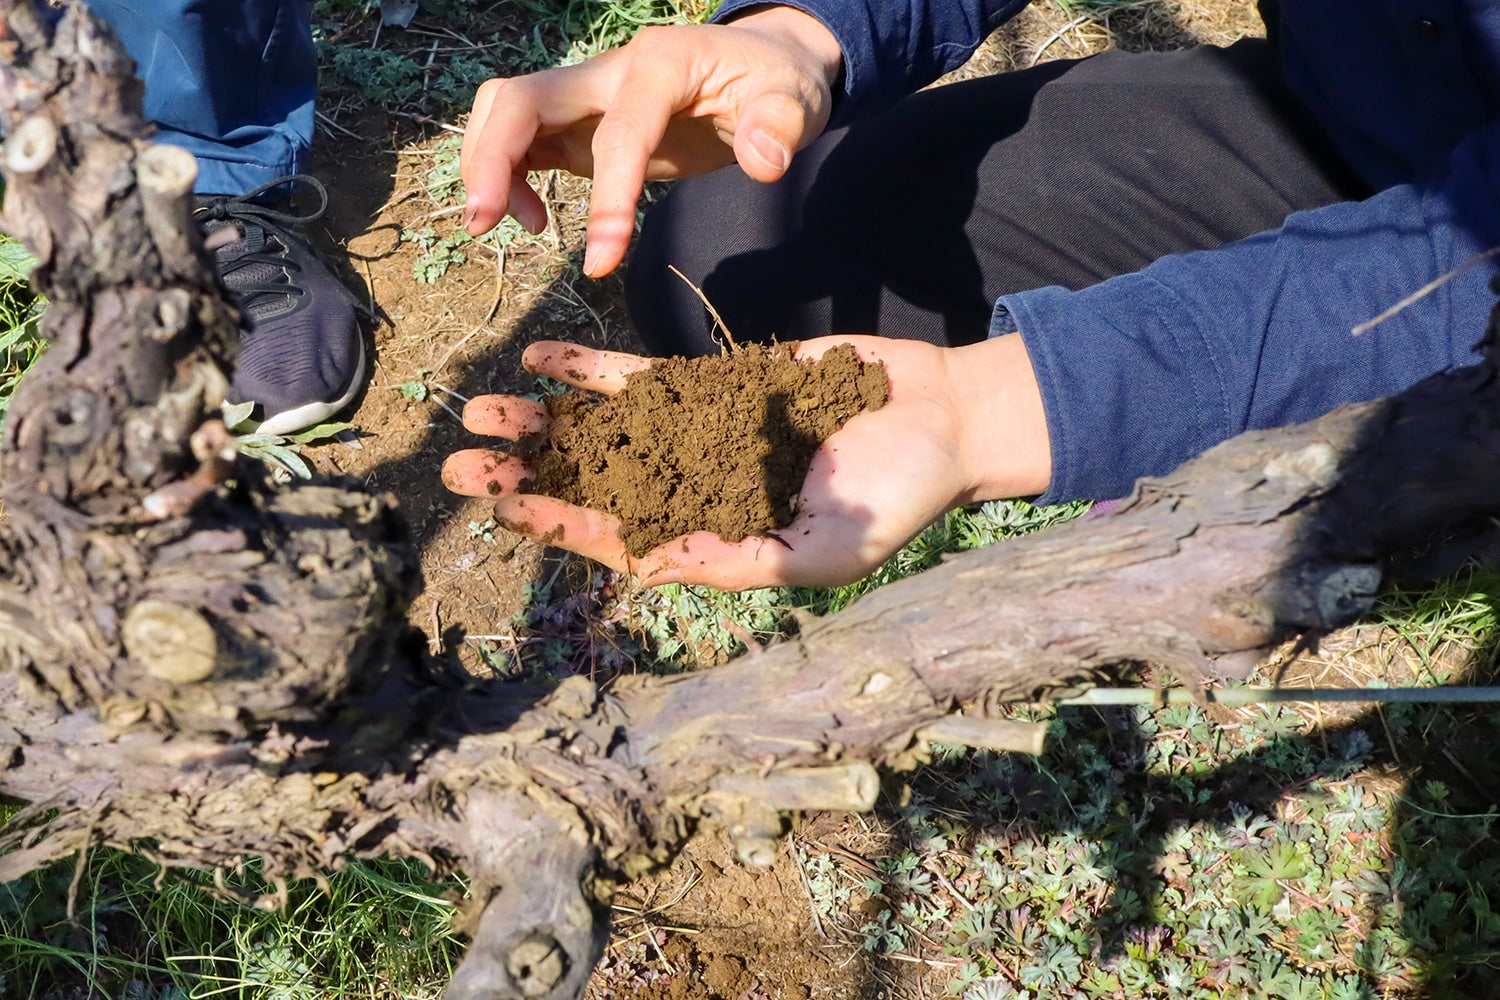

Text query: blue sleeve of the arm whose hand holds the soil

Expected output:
[992,126,1500,502]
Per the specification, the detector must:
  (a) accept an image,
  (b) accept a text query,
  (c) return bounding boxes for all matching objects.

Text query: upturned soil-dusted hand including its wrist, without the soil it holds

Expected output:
[443,337,1050,591]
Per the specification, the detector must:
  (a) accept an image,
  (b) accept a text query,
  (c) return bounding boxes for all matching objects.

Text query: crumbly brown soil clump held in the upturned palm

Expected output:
[519,343,890,556]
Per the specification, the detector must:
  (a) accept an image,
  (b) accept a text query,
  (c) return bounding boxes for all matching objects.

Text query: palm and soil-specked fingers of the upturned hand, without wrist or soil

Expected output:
[444,337,969,589]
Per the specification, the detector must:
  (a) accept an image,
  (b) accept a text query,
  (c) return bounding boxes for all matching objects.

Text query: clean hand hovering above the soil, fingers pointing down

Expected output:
[459,6,843,277]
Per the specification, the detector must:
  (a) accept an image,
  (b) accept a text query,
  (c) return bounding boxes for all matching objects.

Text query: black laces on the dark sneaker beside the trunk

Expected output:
[194,174,329,315]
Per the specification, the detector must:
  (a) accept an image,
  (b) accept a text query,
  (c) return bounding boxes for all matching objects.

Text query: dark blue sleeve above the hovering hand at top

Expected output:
[713,0,1029,124]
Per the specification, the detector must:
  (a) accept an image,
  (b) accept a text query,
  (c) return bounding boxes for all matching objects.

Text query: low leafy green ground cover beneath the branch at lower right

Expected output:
[803,692,1500,1000]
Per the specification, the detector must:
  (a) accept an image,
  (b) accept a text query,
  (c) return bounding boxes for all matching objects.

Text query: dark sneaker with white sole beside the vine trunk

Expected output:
[194,174,365,435]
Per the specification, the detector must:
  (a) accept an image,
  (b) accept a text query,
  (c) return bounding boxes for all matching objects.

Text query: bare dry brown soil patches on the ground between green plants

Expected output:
[283,0,1476,1000]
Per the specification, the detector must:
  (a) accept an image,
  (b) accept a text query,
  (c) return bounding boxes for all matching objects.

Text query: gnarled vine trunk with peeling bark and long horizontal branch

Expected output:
[0,0,1500,1000]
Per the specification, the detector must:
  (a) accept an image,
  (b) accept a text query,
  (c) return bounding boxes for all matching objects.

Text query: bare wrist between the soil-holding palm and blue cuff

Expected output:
[945,334,1052,502]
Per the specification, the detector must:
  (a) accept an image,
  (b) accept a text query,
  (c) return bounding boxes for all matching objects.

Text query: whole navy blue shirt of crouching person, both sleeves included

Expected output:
[716,0,1500,502]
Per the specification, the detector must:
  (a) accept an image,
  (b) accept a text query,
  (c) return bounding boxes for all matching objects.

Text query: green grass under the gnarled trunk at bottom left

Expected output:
[0,839,462,1000]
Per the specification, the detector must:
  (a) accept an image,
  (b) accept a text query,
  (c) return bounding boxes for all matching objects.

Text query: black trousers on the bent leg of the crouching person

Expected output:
[626,39,1370,355]
